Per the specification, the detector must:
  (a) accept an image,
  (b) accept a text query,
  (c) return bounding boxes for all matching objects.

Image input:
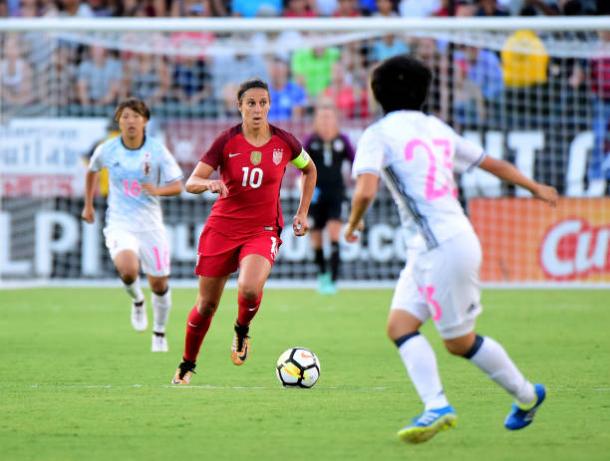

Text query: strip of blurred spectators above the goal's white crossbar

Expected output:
[0,0,608,17]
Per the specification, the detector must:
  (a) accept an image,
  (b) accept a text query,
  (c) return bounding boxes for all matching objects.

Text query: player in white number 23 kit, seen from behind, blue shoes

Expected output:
[345,56,557,443]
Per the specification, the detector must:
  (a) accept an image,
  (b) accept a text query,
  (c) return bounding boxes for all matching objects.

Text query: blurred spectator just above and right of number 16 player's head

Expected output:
[121,53,170,107]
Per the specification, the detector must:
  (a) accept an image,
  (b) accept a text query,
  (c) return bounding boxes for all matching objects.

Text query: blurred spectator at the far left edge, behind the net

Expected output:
[0,35,33,107]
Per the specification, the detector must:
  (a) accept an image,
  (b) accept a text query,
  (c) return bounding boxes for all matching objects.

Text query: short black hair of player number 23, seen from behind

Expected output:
[371,55,432,114]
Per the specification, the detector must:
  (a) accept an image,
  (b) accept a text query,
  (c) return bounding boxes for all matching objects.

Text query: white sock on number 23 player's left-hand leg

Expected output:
[398,334,449,410]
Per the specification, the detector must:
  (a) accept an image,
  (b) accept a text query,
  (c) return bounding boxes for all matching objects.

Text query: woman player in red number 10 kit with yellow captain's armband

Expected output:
[172,80,316,384]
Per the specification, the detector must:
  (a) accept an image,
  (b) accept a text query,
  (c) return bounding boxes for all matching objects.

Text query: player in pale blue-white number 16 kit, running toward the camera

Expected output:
[81,99,182,352]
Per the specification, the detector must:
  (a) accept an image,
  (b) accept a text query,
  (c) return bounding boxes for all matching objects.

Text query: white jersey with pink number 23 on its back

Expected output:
[352,111,485,249]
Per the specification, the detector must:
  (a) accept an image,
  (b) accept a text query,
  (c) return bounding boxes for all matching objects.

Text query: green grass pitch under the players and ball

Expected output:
[0,288,610,461]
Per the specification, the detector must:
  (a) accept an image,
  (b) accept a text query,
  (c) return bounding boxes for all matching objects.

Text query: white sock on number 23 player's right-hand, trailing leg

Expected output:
[470,336,536,405]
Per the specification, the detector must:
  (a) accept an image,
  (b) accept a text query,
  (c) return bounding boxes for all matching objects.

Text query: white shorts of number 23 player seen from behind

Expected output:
[391,231,482,339]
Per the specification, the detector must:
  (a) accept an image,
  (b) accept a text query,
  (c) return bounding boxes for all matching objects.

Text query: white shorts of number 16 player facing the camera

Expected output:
[104,227,170,277]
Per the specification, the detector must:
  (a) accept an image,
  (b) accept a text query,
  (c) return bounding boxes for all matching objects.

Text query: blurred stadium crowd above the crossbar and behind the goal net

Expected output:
[0,0,610,190]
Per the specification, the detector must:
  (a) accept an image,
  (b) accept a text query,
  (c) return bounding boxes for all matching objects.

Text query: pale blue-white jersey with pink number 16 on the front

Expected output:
[89,136,182,232]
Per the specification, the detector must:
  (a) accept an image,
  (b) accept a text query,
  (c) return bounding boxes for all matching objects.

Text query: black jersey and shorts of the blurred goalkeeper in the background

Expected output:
[303,133,354,230]
